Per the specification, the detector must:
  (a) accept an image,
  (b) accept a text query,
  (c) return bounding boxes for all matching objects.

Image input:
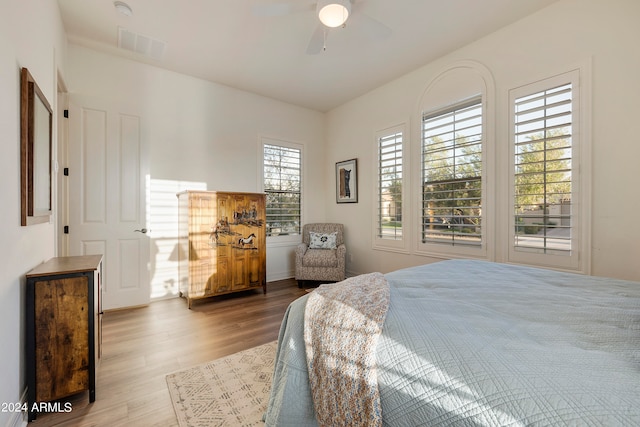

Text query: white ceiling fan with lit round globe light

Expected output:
[254,0,391,55]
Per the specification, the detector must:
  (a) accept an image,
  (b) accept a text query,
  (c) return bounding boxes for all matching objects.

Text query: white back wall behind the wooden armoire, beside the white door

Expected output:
[67,44,325,290]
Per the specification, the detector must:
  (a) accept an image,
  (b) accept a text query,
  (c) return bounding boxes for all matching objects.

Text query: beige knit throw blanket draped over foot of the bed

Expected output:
[304,273,389,427]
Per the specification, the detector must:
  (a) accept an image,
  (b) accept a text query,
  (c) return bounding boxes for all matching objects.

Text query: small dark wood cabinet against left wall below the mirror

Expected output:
[25,255,102,421]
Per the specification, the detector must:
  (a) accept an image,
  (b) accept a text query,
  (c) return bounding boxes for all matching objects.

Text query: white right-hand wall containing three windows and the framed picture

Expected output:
[325,0,640,280]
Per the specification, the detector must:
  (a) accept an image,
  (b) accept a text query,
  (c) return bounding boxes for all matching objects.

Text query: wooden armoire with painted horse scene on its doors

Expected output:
[177,191,267,308]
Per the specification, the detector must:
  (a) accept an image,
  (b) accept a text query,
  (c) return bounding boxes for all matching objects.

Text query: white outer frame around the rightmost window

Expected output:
[505,67,591,274]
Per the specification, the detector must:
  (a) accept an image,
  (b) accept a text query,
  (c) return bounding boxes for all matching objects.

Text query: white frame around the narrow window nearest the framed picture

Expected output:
[371,122,412,253]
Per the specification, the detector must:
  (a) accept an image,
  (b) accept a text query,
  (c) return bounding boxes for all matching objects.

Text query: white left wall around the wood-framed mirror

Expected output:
[0,0,66,426]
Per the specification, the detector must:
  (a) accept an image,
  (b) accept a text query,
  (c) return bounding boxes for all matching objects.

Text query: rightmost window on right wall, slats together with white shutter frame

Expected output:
[510,71,581,269]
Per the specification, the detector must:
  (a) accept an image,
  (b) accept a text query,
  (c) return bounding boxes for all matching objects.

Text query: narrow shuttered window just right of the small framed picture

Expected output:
[374,125,405,249]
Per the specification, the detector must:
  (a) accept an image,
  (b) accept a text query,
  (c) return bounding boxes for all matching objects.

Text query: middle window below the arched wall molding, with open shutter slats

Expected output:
[421,98,483,247]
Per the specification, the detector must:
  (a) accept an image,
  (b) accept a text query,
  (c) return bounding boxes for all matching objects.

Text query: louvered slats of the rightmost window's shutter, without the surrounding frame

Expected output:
[514,83,572,255]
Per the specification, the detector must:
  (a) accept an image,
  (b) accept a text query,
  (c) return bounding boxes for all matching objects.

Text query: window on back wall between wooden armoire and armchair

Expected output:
[263,143,302,236]
